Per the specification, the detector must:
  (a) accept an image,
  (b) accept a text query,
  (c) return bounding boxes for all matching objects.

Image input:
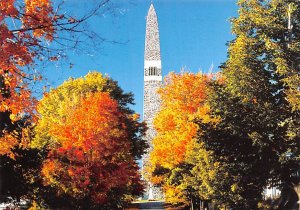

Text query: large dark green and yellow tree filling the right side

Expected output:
[193,0,300,209]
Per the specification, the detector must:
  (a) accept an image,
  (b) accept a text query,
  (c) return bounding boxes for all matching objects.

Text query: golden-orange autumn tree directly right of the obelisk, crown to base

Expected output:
[150,72,218,208]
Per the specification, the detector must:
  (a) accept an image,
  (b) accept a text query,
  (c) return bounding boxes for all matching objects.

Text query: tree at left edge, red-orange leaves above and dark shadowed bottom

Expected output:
[0,0,54,202]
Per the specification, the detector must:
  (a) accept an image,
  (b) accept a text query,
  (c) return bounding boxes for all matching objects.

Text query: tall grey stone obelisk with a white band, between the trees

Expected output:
[143,4,162,200]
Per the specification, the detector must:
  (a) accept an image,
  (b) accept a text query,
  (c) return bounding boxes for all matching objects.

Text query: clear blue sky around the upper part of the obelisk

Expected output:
[45,0,237,116]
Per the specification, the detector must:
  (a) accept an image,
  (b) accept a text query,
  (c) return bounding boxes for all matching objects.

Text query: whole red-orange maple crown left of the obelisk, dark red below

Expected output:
[42,92,142,204]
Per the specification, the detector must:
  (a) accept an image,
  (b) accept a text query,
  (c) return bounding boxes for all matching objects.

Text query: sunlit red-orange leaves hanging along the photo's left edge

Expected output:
[0,0,54,156]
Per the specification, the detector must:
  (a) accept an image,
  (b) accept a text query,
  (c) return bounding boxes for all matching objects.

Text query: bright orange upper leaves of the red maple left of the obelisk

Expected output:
[49,92,128,155]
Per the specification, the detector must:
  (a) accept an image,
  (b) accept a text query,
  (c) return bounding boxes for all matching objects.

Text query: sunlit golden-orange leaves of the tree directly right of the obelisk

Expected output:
[151,72,215,168]
